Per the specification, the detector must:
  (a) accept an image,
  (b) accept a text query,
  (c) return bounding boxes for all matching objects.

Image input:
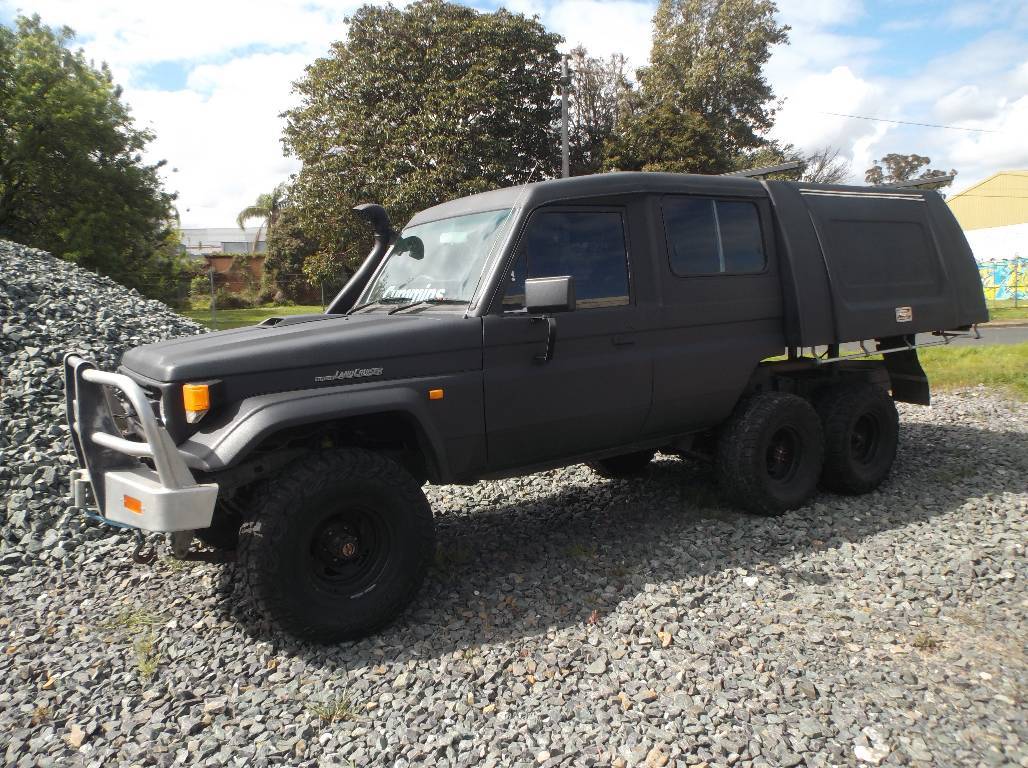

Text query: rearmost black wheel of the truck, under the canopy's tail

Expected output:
[817,383,900,495]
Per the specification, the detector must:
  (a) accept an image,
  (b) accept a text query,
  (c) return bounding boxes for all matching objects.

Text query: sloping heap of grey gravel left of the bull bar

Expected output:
[0,241,204,546]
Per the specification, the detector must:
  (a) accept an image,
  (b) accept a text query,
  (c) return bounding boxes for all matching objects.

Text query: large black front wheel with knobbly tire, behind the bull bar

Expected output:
[236,448,435,643]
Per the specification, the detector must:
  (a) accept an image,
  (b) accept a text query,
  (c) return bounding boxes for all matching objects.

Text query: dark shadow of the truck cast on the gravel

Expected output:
[212,424,1028,669]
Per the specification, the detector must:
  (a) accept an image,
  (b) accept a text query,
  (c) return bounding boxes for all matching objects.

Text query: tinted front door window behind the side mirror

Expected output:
[503,211,629,310]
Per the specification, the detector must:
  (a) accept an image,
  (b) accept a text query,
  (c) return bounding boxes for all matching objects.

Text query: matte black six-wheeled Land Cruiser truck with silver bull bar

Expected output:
[66,173,988,642]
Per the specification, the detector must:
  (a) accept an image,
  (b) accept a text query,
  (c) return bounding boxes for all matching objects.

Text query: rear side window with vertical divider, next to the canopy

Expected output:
[661,196,765,277]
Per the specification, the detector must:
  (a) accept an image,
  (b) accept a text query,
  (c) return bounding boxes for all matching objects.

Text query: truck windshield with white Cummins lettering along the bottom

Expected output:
[358,209,510,304]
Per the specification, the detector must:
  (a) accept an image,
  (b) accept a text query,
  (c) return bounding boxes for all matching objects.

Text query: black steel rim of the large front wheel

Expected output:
[309,506,392,596]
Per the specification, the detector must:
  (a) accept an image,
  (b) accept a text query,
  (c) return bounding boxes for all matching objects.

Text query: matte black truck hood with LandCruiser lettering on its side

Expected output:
[121,313,482,386]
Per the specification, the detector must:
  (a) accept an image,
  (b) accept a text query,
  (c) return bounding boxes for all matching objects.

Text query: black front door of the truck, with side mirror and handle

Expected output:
[483,207,652,471]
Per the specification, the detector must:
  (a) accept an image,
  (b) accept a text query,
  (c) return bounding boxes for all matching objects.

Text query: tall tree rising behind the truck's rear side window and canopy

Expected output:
[618,0,788,173]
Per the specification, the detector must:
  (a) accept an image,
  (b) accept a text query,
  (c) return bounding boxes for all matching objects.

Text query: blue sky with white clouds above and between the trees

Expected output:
[0,0,1028,226]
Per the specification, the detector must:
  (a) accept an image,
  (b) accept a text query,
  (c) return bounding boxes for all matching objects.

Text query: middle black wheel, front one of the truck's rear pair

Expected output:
[717,392,824,515]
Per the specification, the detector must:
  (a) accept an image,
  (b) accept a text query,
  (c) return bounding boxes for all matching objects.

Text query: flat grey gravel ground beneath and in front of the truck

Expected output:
[0,389,1028,768]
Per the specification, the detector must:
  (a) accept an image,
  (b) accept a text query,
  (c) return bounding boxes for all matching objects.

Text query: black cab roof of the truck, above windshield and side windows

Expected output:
[408,172,767,225]
